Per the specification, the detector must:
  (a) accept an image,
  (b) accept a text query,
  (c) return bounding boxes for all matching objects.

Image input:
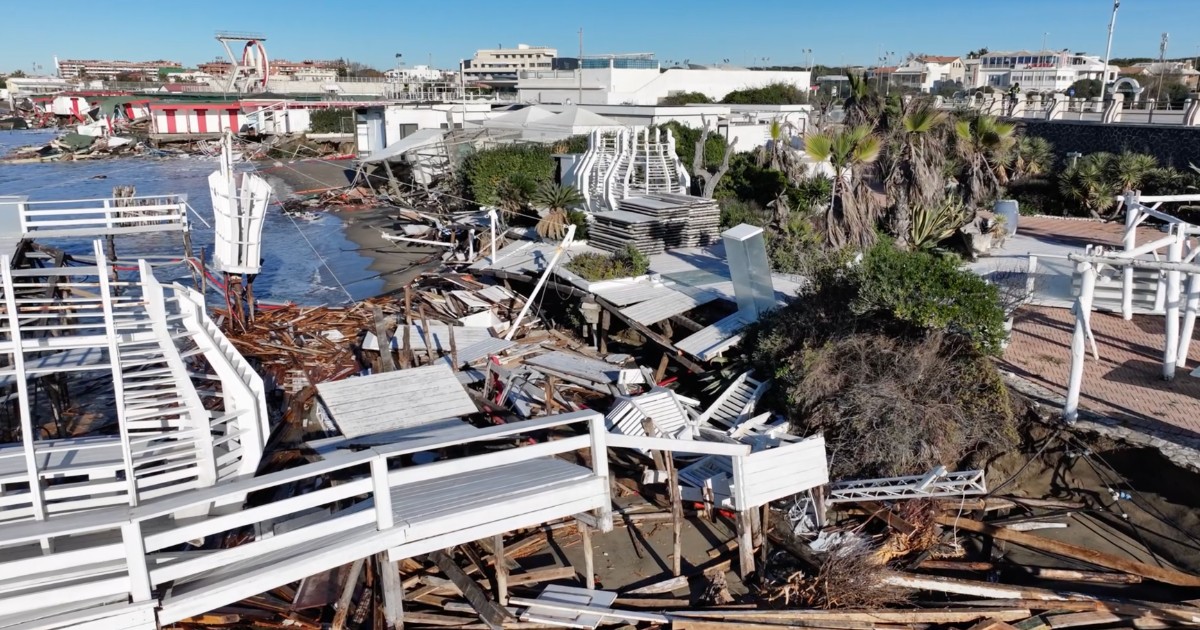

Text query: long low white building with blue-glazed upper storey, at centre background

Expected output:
[517,53,811,106]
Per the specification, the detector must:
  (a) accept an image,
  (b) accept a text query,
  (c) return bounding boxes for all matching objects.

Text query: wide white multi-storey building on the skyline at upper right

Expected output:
[968,50,1120,92]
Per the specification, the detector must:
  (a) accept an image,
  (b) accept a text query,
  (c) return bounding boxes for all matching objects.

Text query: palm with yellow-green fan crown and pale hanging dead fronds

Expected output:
[804,125,882,248]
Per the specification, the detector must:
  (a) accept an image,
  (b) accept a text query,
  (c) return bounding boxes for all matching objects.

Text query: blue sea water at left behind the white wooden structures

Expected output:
[0,131,383,305]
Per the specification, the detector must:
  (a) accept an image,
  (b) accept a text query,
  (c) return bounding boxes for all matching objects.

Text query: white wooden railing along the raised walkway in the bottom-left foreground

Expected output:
[0,412,612,624]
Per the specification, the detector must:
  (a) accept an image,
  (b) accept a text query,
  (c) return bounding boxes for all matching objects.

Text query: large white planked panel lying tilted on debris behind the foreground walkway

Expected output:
[317,364,478,438]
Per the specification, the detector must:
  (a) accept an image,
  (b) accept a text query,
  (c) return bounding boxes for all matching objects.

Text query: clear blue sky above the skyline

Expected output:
[0,0,1200,72]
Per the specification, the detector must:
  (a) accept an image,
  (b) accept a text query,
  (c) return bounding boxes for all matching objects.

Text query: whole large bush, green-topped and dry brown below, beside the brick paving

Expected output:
[743,242,1016,478]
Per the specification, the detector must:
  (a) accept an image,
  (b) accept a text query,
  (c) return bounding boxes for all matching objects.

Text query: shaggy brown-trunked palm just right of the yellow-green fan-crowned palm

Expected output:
[886,100,946,245]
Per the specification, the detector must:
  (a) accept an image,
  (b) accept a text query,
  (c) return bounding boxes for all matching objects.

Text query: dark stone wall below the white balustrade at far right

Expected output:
[1018,120,1200,169]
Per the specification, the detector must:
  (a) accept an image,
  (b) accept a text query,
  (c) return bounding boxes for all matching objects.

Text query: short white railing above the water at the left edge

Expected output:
[17,194,188,239]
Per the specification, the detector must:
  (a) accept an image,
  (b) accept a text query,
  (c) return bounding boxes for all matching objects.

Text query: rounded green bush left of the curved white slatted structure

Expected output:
[461,144,554,205]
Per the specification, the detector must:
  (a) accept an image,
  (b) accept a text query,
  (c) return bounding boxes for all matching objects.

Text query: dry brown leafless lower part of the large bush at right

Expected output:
[787,335,1018,478]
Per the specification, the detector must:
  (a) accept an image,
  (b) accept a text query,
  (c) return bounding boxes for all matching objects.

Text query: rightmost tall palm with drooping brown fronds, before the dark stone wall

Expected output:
[954,114,1015,208]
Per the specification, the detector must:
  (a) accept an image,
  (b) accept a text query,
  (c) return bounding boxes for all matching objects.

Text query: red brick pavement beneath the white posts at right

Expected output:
[1001,304,1200,438]
